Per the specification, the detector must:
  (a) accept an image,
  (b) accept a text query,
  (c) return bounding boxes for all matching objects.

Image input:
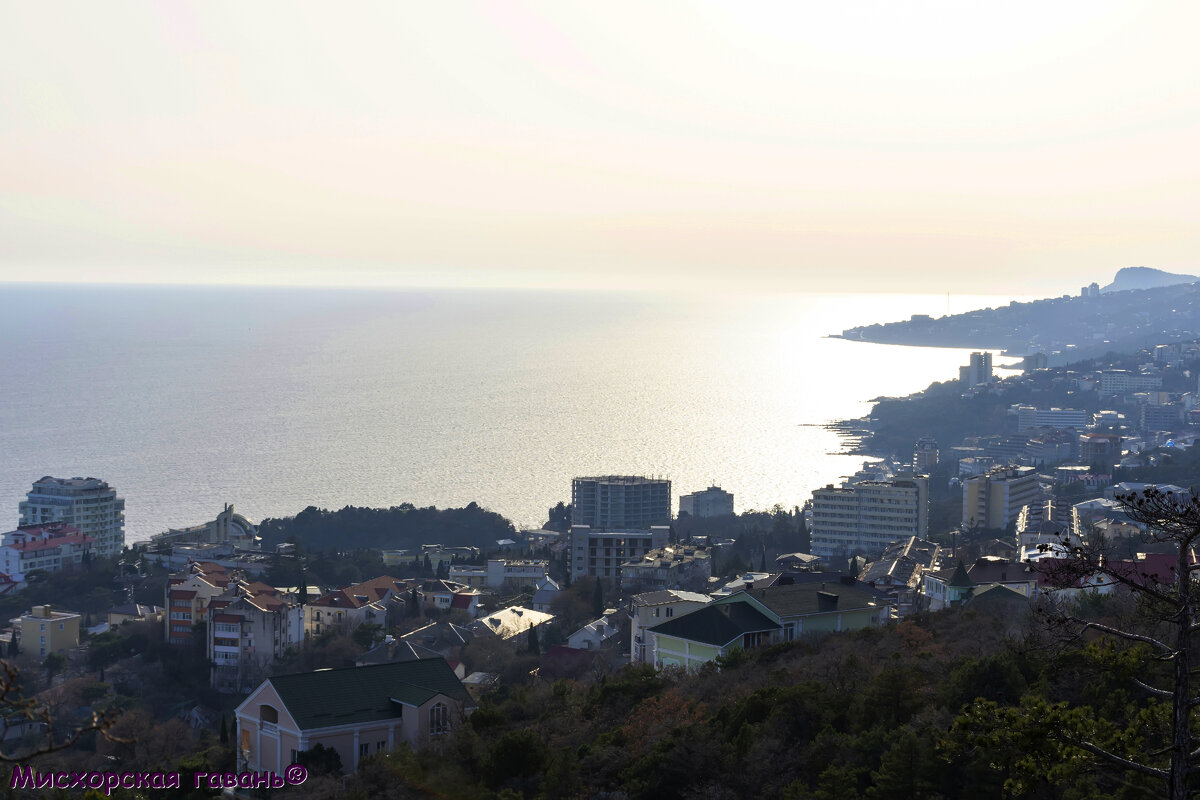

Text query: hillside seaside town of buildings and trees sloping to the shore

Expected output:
[7,277,1200,798]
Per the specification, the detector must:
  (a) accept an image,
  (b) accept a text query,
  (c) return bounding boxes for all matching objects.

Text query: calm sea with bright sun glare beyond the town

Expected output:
[0,285,1009,541]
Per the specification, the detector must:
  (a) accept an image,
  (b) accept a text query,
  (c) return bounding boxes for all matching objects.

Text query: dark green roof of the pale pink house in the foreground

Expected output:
[268,657,473,730]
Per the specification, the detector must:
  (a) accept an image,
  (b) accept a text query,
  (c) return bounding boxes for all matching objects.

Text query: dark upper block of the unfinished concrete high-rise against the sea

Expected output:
[571,475,671,530]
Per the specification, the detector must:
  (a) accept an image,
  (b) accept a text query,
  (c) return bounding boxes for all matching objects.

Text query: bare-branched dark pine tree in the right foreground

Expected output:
[1043,487,1200,800]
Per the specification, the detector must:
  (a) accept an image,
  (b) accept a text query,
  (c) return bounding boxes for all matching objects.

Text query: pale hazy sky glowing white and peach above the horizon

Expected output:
[0,0,1200,294]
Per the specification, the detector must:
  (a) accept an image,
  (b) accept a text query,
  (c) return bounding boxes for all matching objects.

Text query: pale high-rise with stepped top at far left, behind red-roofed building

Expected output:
[20,475,125,555]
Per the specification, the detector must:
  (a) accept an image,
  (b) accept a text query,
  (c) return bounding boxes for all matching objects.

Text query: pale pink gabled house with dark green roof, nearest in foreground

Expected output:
[234,657,475,774]
